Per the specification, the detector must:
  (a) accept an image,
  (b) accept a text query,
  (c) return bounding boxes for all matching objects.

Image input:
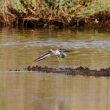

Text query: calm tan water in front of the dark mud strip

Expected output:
[0,73,110,110]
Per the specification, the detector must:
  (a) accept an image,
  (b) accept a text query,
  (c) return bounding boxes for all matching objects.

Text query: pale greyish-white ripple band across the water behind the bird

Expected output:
[0,40,110,48]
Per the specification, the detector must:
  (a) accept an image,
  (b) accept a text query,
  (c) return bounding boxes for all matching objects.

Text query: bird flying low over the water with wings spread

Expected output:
[34,49,70,62]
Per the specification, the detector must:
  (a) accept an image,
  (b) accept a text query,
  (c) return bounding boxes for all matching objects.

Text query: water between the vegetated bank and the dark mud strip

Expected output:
[0,28,110,70]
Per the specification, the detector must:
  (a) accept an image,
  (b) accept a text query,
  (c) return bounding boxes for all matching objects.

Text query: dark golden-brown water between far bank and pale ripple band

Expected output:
[0,28,110,42]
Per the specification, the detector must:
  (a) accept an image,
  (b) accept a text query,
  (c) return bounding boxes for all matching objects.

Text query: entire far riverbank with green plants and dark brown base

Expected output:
[0,0,110,31]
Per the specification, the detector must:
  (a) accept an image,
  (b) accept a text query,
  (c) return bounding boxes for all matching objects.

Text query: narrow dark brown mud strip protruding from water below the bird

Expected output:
[16,65,110,77]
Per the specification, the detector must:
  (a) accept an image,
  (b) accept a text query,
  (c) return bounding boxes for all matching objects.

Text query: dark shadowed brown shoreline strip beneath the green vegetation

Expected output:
[0,12,110,32]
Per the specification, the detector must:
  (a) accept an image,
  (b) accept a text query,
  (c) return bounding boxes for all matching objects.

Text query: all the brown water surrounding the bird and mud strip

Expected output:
[0,28,110,110]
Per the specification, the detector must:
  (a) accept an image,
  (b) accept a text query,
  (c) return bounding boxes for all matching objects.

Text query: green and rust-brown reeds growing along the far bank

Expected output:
[0,0,110,26]
